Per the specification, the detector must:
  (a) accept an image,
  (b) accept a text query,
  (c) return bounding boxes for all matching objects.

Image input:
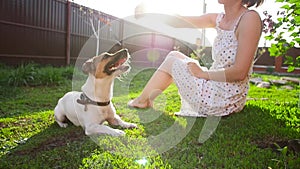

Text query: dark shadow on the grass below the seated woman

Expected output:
[155,104,300,168]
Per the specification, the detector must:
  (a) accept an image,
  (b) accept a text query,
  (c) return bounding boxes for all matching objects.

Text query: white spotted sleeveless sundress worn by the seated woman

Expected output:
[161,13,252,117]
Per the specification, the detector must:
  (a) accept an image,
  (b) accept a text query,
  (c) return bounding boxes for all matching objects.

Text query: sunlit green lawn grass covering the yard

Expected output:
[0,66,300,169]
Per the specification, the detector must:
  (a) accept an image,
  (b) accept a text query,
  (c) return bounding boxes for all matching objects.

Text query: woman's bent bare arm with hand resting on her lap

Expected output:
[188,11,262,82]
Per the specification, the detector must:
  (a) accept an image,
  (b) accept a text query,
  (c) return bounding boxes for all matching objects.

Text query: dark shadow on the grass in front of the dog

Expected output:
[0,123,97,168]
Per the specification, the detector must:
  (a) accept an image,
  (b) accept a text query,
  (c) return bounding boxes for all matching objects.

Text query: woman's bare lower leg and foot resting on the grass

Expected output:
[128,69,173,108]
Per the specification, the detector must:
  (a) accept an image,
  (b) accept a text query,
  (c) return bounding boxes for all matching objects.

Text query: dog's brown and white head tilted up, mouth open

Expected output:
[82,49,130,79]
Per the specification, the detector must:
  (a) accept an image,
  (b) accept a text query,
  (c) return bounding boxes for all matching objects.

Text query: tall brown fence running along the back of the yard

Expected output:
[0,0,299,73]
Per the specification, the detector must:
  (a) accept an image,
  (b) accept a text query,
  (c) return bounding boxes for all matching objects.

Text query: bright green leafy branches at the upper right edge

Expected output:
[263,0,300,72]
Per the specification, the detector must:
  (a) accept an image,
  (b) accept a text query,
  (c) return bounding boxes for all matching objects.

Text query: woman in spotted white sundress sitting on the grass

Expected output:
[128,0,264,117]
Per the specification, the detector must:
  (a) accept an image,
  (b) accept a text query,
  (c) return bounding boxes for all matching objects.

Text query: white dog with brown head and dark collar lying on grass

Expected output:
[54,49,137,136]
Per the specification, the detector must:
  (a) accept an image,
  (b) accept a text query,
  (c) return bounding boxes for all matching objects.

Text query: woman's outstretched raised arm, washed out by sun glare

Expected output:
[168,13,218,28]
